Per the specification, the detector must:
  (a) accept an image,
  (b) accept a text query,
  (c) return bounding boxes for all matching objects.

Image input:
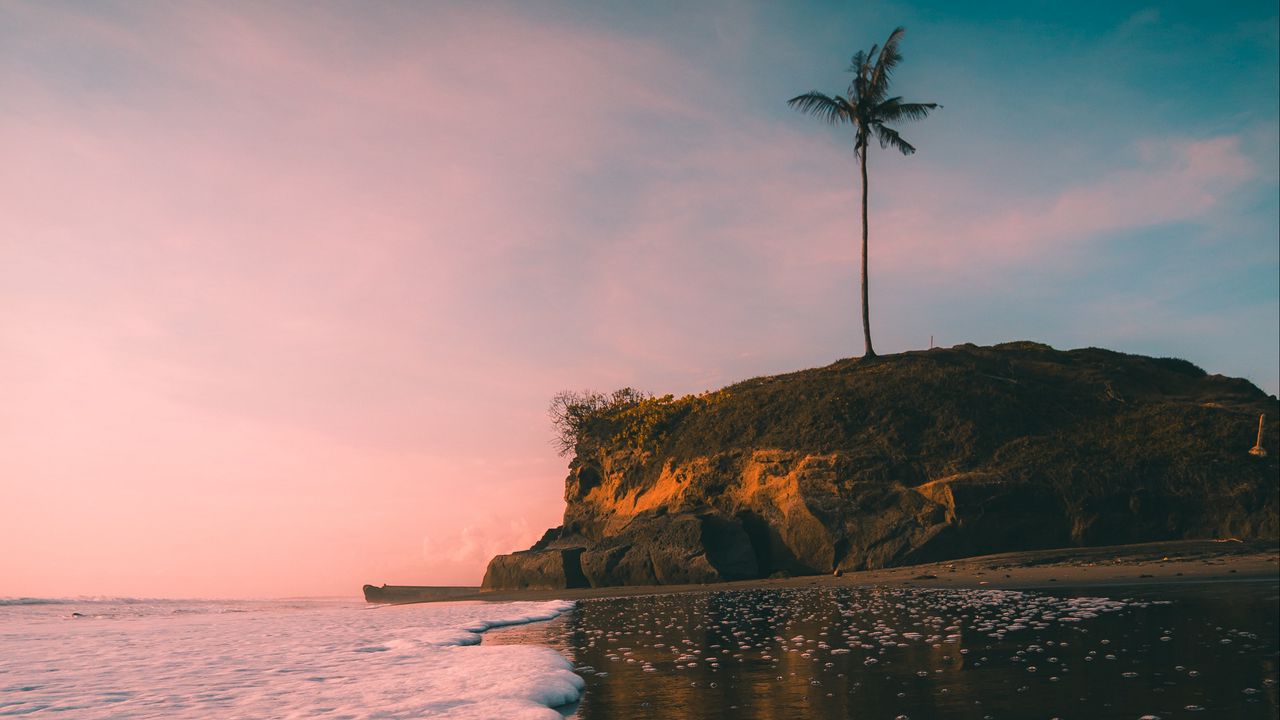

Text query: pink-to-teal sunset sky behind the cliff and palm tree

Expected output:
[0,0,1280,597]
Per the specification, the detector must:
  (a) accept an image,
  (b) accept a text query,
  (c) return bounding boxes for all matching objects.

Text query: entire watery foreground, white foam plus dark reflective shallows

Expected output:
[0,582,1280,720]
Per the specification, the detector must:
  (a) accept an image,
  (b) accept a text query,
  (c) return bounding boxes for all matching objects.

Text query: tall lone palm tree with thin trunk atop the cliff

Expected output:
[787,27,941,357]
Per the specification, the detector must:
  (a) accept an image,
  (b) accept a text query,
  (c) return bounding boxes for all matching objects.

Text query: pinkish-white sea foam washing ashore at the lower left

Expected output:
[0,598,582,720]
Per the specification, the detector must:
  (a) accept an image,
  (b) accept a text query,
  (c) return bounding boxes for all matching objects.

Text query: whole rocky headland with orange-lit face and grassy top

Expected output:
[484,343,1280,588]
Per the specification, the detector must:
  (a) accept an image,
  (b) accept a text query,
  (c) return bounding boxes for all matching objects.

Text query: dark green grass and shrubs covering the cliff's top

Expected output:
[562,342,1277,484]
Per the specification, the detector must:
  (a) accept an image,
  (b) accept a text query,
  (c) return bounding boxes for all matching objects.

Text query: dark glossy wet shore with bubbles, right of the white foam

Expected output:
[485,583,1280,720]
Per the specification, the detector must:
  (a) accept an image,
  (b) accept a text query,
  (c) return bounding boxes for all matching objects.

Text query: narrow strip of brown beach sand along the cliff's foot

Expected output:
[435,539,1280,601]
